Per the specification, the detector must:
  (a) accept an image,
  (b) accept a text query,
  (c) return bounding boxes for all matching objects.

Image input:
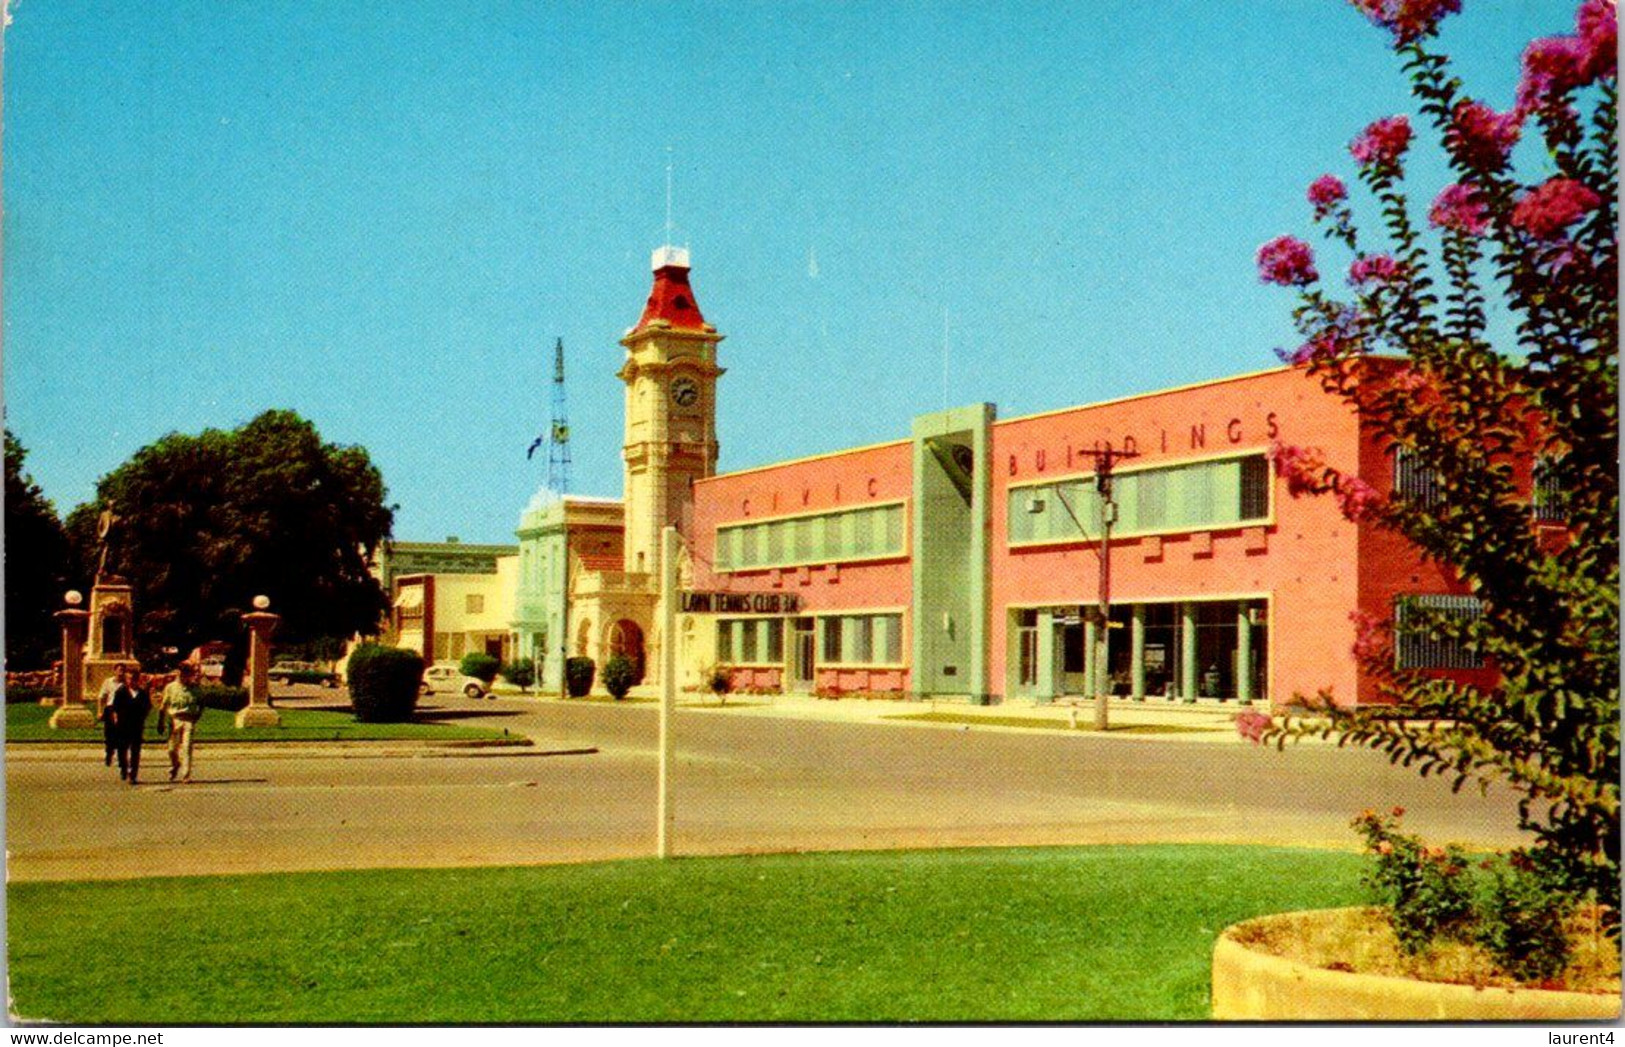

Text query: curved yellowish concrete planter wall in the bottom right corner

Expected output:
[1212,909,1620,1021]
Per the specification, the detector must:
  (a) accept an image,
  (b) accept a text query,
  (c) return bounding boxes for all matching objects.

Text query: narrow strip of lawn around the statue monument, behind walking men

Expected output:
[5,702,504,746]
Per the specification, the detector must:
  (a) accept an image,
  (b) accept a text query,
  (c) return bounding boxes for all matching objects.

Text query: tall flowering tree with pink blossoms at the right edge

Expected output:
[1258,0,1620,927]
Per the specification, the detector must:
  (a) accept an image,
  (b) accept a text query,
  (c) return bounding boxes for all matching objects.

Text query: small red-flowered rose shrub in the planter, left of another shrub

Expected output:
[1354,806,1472,954]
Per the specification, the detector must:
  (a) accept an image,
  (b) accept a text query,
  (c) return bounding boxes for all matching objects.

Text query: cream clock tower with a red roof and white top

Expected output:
[618,245,723,585]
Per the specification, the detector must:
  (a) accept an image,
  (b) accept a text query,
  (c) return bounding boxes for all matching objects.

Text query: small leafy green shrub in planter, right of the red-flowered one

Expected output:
[1474,852,1575,982]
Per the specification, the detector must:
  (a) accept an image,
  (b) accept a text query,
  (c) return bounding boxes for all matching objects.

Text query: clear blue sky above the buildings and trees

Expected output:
[3,0,1573,541]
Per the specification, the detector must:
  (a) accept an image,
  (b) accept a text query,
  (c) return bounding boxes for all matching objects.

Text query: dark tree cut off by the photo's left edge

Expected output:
[5,429,68,670]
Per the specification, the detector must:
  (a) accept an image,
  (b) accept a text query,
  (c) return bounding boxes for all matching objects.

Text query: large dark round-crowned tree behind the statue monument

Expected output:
[68,411,395,676]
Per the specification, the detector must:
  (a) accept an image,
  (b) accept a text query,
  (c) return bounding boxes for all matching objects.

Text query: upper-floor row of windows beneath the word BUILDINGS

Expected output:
[1008,454,1269,545]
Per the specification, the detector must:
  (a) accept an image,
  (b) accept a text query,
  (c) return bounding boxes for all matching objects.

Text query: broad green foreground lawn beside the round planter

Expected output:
[7,845,1363,1024]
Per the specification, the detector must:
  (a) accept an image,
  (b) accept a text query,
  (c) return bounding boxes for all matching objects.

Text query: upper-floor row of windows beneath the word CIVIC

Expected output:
[715,504,904,571]
